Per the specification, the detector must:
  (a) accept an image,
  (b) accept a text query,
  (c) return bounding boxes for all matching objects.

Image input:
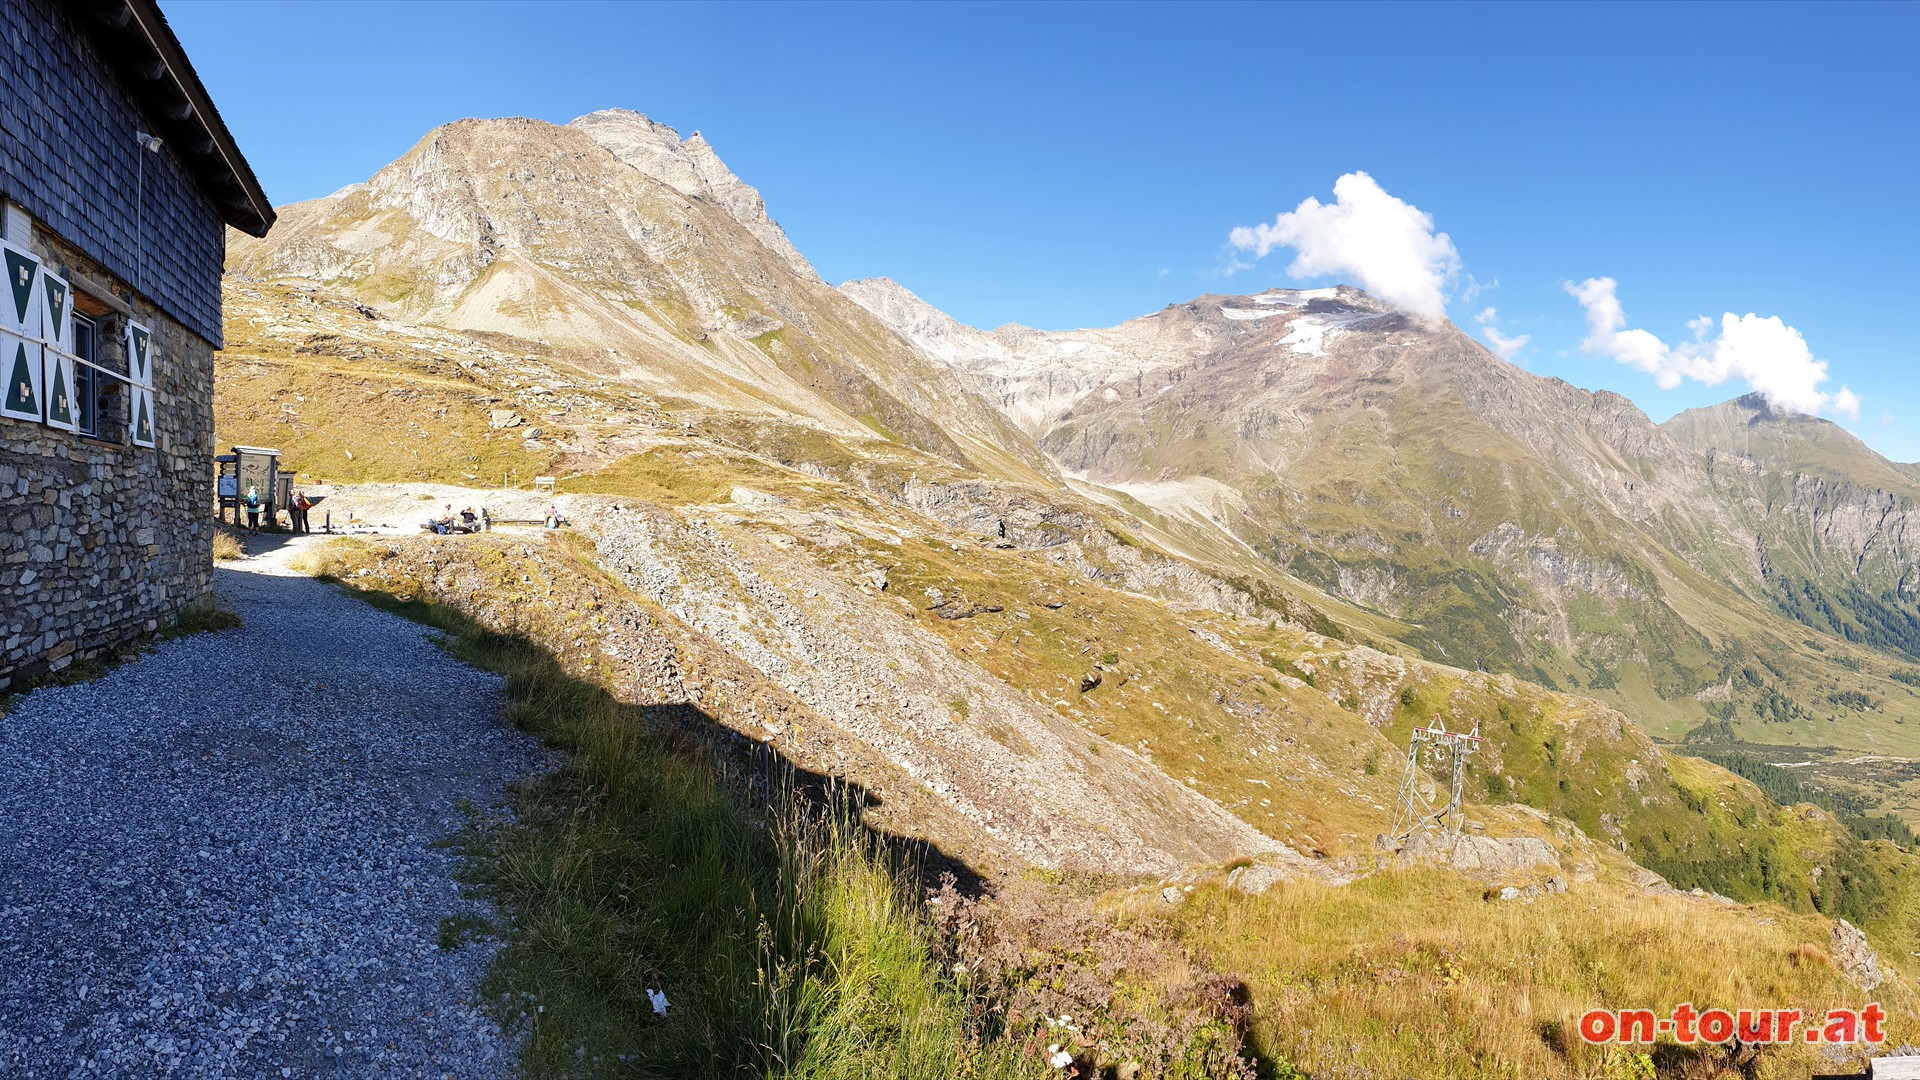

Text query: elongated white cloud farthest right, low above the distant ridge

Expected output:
[1567,277,1860,419]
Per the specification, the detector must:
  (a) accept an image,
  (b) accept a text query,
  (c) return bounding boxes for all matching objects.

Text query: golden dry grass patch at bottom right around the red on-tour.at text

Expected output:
[1177,871,1914,1080]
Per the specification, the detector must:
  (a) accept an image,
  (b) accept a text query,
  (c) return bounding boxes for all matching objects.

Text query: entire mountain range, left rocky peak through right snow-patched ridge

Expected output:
[230,110,1920,748]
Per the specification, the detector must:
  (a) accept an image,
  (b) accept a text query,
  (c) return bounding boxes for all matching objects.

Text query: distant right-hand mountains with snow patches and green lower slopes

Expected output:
[843,281,1920,749]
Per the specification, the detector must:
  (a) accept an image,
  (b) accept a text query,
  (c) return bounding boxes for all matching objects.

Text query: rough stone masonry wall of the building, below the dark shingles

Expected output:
[0,225,213,692]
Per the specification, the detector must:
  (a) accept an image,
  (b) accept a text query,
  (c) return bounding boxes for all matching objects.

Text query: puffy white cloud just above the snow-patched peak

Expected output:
[1227,173,1459,319]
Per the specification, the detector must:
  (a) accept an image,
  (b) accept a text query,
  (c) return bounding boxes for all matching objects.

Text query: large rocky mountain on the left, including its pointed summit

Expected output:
[228,110,1050,479]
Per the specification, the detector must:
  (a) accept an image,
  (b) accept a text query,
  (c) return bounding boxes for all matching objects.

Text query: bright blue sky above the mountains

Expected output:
[163,0,1920,461]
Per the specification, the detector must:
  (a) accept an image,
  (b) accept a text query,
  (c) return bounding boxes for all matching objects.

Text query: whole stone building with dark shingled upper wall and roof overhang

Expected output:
[0,0,275,687]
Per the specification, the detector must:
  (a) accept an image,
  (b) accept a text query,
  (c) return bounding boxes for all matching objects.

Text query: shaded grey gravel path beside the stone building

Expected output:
[0,541,551,1080]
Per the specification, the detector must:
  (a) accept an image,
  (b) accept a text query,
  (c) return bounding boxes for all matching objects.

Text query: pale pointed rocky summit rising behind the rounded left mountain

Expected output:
[566,110,820,281]
